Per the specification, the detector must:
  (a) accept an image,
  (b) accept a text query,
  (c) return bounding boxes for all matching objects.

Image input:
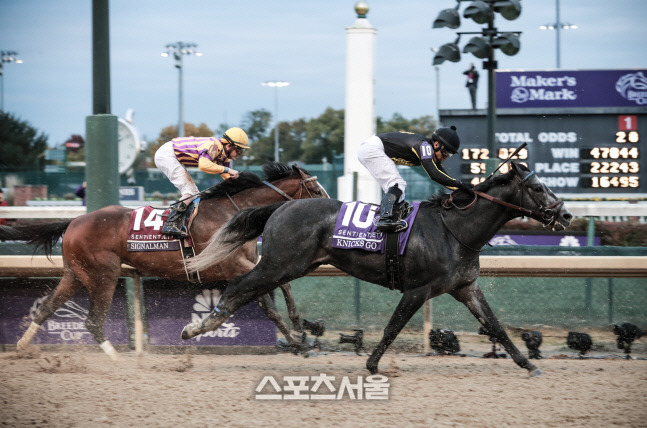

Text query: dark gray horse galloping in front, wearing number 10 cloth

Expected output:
[182,162,572,375]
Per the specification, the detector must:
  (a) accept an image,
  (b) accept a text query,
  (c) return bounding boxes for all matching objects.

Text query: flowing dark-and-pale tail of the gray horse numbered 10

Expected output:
[186,201,287,272]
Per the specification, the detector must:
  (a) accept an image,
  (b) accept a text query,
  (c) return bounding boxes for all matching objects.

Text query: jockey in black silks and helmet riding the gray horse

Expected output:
[357,126,472,232]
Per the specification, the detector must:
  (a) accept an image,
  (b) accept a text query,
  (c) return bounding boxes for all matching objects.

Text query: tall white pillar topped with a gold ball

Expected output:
[337,1,382,203]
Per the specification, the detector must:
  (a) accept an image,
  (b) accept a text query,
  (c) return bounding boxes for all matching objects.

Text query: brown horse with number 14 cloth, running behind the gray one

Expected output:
[0,162,328,359]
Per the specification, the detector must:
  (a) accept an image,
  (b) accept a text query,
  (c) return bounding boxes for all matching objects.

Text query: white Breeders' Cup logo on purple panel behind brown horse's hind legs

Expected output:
[29,296,90,342]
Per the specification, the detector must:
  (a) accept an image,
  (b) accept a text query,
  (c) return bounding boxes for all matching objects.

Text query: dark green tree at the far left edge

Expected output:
[0,111,47,170]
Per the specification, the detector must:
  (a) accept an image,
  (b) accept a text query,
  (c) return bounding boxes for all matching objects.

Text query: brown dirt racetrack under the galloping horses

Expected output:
[0,337,647,427]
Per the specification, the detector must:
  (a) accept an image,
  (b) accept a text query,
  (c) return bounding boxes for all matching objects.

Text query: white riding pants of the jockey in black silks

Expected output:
[357,135,407,202]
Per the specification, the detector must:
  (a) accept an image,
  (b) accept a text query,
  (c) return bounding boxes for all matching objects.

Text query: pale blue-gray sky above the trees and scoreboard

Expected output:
[0,0,647,147]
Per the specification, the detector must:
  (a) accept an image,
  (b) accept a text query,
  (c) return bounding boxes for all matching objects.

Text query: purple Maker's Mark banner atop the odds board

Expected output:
[496,69,647,108]
